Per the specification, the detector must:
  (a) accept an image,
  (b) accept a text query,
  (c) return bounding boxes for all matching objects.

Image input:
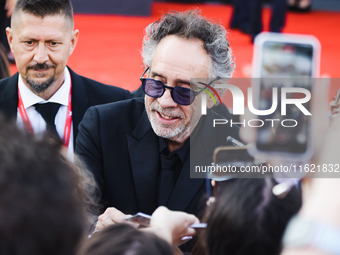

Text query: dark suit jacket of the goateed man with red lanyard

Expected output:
[0,68,131,147]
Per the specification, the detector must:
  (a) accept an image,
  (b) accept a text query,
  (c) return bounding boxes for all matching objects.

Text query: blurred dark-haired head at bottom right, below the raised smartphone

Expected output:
[197,178,301,255]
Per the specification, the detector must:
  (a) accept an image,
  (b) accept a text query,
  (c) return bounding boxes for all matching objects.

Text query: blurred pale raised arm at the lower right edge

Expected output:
[281,116,340,255]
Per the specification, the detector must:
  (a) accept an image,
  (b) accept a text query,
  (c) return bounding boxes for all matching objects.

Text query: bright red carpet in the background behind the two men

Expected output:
[12,3,340,97]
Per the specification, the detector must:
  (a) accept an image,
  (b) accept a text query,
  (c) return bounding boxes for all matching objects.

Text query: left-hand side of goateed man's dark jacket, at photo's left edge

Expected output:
[0,73,19,118]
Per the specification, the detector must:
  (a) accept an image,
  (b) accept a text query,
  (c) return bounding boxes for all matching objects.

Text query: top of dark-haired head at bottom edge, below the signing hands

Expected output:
[78,223,173,255]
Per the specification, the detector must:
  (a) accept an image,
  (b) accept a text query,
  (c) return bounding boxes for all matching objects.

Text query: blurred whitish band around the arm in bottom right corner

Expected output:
[283,216,340,255]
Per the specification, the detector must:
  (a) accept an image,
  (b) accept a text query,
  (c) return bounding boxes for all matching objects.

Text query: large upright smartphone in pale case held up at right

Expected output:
[250,33,320,160]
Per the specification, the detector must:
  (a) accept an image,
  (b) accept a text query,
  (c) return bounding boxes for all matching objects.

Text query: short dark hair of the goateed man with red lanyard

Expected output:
[13,0,73,22]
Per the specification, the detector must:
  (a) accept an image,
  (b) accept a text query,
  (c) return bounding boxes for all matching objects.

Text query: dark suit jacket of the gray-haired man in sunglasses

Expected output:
[76,98,238,215]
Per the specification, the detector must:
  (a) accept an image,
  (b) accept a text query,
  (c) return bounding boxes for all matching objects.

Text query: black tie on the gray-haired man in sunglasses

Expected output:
[158,151,180,205]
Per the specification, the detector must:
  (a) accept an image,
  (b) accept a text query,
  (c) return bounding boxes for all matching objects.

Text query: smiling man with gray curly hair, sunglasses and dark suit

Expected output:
[76,11,238,230]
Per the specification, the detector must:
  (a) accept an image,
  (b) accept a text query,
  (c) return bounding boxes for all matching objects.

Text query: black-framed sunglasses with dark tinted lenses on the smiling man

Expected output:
[140,67,203,105]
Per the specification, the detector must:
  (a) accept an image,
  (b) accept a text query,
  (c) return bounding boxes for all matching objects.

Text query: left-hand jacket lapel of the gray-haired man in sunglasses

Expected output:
[127,111,159,213]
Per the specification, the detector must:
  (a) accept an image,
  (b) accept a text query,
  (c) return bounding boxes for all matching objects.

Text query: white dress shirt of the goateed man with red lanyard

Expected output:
[17,67,74,158]
